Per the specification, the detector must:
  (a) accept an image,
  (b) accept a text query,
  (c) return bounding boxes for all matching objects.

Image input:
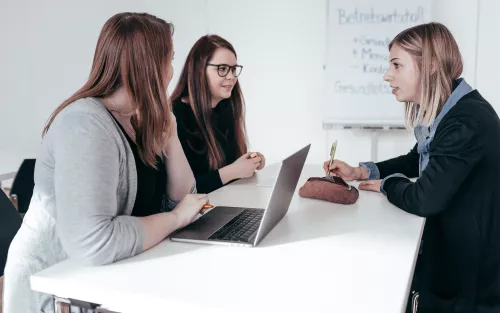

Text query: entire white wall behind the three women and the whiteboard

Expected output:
[0,0,494,168]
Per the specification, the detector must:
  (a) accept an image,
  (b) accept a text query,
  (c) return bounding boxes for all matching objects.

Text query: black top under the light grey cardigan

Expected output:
[111,114,167,216]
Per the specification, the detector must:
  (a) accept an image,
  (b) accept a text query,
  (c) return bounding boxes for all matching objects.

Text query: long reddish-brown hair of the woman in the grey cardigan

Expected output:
[43,13,173,168]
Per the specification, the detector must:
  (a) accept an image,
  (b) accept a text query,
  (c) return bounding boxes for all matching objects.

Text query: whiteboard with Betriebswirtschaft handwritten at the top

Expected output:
[323,0,432,125]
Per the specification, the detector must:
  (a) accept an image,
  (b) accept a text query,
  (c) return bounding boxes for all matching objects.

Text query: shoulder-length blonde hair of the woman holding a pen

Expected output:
[389,23,463,128]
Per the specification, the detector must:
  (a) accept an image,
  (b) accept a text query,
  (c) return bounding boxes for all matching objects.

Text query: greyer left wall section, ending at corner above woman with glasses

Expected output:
[0,0,206,154]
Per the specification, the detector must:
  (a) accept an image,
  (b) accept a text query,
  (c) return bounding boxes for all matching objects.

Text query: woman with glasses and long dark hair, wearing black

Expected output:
[171,35,265,193]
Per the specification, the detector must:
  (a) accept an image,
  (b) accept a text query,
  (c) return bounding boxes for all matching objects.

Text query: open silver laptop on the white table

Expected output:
[170,144,311,247]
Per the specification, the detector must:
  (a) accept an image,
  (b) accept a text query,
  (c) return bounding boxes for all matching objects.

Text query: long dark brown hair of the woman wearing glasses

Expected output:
[171,35,247,170]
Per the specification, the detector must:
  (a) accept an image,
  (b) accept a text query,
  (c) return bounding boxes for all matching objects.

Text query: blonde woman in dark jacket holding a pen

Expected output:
[324,23,500,313]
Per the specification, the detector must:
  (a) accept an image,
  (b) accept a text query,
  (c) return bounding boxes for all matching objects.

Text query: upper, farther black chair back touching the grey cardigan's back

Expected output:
[10,159,36,214]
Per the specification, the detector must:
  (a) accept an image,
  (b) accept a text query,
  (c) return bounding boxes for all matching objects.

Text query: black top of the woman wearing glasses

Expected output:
[172,100,237,193]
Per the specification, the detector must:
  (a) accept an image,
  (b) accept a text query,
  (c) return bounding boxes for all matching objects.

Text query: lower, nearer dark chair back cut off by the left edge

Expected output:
[0,190,21,276]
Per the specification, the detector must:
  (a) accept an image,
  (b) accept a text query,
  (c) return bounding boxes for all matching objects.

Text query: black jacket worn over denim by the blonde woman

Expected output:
[377,90,500,313]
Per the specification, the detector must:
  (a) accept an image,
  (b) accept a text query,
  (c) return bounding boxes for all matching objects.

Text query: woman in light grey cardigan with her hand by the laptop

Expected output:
[4,13,208,313]
